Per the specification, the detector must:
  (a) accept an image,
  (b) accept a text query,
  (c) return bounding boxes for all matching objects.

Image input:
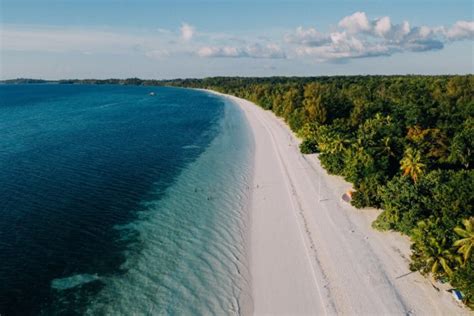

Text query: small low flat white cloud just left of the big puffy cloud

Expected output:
[197,44,286,59]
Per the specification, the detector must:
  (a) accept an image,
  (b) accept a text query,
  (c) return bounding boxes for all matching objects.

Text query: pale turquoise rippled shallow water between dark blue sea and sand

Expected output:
[88,97,252,315]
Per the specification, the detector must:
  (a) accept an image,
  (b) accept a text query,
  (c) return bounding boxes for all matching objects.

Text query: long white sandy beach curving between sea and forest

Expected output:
[208,90,471,315]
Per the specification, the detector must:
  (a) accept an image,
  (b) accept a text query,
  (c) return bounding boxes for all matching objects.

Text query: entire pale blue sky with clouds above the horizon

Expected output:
[0,0,474,79]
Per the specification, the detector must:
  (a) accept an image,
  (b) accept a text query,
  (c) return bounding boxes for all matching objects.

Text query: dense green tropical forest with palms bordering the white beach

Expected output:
[165,75,474,307]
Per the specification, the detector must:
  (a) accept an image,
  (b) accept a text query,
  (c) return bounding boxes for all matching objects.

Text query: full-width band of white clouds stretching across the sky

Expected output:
[0,12,474,62]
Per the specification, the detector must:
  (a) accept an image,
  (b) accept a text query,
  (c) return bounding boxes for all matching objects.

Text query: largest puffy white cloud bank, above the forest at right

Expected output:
[286,12,474,61]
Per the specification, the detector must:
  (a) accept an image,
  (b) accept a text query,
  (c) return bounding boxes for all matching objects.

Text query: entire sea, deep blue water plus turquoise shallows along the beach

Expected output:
[0,84,253,316]
